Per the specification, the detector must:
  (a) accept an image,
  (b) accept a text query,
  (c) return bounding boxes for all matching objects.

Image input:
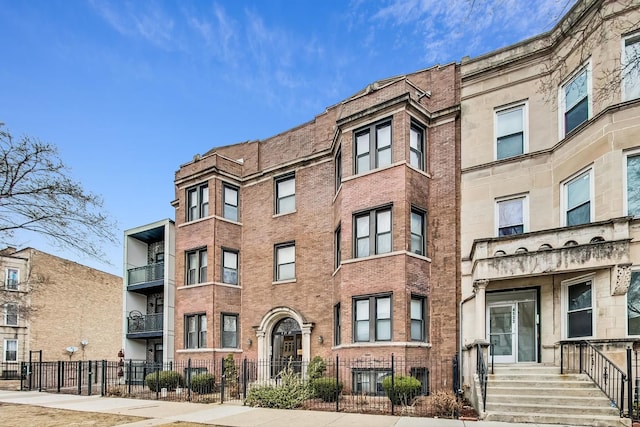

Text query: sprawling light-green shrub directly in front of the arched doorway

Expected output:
[244,362,313,409]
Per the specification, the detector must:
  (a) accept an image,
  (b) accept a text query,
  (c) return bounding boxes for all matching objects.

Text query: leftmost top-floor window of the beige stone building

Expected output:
[495,104,525,160]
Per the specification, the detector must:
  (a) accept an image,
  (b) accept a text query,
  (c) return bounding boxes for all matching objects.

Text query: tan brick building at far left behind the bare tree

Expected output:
[0,248,122,372]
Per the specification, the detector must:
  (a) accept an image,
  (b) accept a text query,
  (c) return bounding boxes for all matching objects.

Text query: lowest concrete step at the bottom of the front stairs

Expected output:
[484,412,631,427]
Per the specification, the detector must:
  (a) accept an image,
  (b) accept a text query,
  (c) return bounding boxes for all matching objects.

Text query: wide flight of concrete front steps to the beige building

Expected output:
[485,365,631,427]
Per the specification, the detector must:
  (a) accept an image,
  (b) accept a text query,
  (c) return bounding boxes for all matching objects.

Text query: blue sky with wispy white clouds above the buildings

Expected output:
[0,0,574,275]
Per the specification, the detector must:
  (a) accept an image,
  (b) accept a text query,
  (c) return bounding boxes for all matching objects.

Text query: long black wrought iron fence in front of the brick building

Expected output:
[17,355,460,416]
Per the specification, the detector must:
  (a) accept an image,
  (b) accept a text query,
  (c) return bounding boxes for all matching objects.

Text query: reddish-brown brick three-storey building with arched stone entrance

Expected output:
[173,64,460,386]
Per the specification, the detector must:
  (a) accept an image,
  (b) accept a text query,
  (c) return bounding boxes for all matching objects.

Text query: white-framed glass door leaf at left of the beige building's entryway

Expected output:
[489,304,516,363]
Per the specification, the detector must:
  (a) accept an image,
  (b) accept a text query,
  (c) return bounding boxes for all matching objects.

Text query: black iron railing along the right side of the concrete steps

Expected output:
[560,341,631,417]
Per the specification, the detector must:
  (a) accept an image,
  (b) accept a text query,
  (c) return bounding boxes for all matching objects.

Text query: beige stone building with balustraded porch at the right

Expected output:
[460,0,640,422]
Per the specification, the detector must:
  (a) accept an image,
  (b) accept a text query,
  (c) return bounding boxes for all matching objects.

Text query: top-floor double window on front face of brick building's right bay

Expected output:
[355,120,391,174]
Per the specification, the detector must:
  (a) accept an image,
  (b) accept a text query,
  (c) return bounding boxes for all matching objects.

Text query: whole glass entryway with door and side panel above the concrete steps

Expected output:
[487,293,538,363]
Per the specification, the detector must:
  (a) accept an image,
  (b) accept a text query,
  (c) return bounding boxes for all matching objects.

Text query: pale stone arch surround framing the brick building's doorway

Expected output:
[256,307,313,380]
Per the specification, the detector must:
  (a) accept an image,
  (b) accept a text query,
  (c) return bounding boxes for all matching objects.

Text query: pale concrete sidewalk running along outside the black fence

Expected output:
[0,390,576,427]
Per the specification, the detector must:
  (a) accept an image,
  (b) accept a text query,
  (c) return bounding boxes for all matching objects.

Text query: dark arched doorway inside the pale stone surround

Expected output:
[271,317,302,376]
